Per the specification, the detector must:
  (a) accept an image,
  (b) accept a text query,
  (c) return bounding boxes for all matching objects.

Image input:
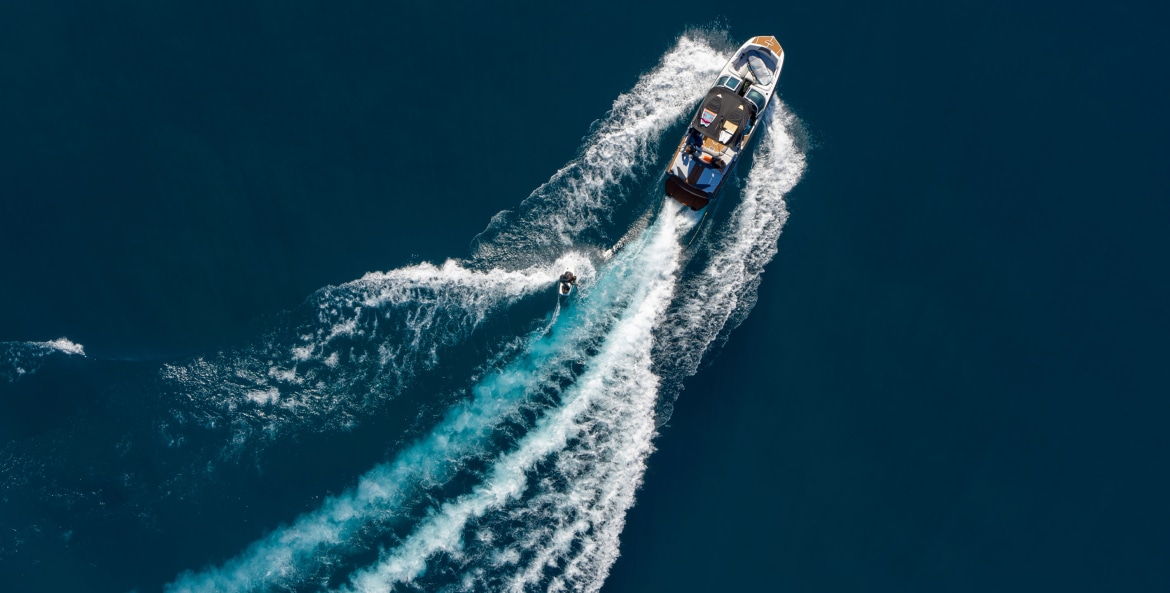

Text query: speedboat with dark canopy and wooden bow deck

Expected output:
[666,36,784,211]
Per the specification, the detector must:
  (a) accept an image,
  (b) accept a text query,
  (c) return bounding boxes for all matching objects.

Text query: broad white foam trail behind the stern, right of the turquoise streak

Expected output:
[336,204,695,593]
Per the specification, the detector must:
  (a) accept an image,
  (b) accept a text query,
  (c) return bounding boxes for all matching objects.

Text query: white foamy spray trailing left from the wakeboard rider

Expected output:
[161,253,594,455]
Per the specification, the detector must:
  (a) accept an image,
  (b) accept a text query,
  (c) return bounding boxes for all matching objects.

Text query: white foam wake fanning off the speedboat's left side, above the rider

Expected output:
[473,35,727,266]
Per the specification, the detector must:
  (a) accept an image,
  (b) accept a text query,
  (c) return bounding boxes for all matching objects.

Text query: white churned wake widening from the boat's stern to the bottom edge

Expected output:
[336,202,683,592]
